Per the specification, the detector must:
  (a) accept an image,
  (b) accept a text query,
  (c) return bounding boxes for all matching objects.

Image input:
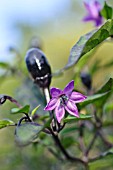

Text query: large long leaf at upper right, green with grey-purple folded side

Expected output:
[62,20,113,71]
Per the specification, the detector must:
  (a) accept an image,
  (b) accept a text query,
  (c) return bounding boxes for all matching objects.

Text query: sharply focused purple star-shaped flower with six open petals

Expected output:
[44,80,86,123]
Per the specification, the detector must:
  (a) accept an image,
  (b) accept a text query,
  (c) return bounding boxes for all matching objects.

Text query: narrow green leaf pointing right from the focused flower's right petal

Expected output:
[78,92,110,109]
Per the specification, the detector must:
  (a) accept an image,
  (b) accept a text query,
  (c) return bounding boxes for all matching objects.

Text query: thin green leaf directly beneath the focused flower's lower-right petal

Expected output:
[64,114,92,122]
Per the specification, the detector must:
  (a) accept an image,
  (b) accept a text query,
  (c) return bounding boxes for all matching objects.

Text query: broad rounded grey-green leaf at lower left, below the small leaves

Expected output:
[15,123,42,146]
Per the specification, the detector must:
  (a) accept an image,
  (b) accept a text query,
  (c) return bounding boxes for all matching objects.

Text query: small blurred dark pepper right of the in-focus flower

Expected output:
[80,72,92,90]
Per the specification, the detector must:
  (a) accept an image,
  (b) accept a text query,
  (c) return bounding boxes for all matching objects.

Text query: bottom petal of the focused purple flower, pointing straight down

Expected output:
[55,102,65,123]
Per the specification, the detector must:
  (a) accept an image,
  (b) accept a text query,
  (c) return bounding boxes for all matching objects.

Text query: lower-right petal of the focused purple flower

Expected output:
[65,100,79,117]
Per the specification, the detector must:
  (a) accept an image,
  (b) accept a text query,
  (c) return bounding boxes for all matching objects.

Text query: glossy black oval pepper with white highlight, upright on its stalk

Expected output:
[25,48,51,88]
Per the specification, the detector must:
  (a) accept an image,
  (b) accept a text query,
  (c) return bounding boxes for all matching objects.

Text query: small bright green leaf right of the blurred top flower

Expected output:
[100,1,113,19]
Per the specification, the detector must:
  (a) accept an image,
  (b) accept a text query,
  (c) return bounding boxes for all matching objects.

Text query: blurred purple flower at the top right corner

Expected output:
[83,0,103,26]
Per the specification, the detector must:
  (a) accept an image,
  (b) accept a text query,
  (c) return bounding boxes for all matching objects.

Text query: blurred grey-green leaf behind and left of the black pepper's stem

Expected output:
[16,78,47,116]
